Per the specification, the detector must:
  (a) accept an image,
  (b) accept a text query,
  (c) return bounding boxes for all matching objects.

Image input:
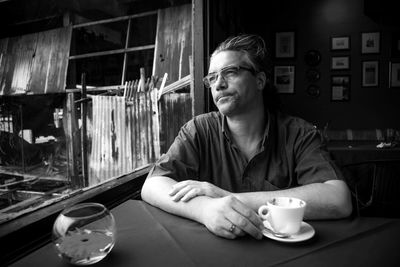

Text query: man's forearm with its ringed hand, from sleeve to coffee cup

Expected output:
[142,176,263,239]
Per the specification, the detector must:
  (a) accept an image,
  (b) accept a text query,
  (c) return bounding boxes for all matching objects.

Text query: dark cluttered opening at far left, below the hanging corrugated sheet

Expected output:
[0,94,72,220]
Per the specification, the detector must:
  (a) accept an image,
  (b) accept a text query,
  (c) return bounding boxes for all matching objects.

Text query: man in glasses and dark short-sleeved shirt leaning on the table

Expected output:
[142,35,352,239]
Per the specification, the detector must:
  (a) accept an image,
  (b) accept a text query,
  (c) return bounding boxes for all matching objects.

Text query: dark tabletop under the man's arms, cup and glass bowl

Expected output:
[11,200,400,267]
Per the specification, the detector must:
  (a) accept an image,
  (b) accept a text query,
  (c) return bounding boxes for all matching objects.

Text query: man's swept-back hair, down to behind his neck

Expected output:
[211,34,280,111]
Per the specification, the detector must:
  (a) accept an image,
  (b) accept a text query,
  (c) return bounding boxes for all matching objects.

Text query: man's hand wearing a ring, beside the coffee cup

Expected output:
[202,196,264,239]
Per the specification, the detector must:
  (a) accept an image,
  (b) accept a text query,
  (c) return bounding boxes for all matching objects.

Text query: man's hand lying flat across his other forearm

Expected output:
[169,180,230,202]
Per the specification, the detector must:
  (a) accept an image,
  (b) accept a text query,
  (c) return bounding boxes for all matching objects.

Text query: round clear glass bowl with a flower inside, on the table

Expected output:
[52,203,116,265]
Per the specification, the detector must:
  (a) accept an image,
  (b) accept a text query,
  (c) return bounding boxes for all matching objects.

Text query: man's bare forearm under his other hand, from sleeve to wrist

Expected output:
[141,176,209,223]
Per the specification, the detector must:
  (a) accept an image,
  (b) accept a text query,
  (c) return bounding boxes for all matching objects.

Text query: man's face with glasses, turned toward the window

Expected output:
[208,51,263,117]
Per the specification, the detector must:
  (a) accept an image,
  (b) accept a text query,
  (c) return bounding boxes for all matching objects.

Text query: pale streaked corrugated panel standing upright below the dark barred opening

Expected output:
[88,92,160,185]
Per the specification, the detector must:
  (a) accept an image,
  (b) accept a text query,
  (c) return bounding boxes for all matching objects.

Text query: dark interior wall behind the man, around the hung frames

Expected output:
[211,0,400,129]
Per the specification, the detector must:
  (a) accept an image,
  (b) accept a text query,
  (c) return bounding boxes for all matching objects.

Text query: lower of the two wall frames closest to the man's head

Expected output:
[274,65,295,94]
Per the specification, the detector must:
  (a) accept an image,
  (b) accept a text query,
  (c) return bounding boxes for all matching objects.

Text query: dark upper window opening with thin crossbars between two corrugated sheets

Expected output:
[67,11,157,88]
